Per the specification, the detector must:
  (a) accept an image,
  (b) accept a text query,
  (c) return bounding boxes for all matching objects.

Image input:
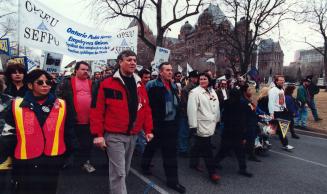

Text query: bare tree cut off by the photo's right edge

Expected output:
[300,0,327,91]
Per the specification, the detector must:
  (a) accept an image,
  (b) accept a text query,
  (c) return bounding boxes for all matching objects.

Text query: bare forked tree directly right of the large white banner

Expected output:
[93,0,204,53]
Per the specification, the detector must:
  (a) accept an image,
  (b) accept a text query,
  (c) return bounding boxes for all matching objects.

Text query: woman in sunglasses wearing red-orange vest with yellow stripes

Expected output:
[6,69,76,194]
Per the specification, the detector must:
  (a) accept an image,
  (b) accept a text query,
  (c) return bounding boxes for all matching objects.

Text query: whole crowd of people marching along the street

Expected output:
[0,50,321,194]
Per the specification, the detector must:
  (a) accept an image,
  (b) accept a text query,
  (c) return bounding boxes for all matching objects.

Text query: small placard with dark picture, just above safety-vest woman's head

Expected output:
[43,52,63,73]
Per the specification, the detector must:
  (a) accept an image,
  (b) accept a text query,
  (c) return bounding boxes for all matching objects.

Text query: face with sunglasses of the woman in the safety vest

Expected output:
[28,75,51,96]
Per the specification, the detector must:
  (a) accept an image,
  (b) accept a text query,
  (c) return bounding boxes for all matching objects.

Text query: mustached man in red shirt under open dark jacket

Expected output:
[56,61,95,173]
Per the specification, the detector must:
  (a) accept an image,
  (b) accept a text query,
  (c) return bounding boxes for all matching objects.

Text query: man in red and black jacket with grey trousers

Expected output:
[91,50,153,194]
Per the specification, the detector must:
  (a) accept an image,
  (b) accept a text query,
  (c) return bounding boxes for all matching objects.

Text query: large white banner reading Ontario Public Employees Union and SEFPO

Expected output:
[19,0,138,60]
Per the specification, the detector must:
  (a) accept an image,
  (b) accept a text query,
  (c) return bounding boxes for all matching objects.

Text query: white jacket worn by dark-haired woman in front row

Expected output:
[187,86,220,137]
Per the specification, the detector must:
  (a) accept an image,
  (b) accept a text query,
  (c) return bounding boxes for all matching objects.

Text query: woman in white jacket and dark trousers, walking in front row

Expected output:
[187,73,220,183]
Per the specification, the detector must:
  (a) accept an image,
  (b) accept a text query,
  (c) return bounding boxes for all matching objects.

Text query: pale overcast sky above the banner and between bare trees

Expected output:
[7,0,322,65]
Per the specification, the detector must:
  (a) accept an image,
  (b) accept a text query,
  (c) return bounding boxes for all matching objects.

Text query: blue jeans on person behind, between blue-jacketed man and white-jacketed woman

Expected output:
[178,116,190,153]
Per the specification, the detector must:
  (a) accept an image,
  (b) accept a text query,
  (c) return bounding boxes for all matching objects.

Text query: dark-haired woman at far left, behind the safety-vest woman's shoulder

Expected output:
[4,63,28,97]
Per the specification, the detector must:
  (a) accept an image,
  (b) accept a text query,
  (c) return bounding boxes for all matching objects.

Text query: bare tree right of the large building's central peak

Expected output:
[222,0,294,74]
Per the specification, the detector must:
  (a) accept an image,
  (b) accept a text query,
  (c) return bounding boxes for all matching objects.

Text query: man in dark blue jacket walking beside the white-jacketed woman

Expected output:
[142,62,186,193]
